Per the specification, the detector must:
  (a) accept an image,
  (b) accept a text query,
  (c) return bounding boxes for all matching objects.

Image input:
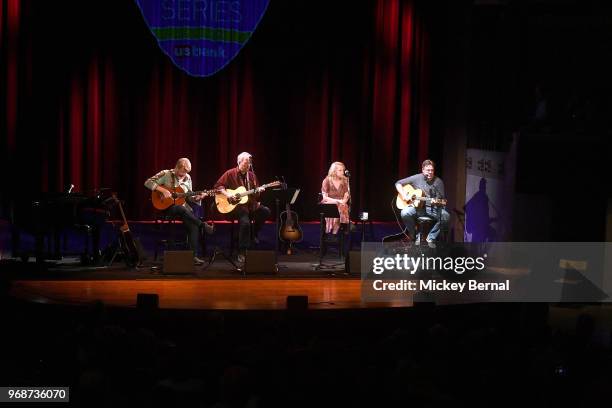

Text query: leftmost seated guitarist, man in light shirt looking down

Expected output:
[145,157,213,265]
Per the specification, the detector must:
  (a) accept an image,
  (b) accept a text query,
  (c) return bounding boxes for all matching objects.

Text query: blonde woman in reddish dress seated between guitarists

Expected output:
[321,162,351,234]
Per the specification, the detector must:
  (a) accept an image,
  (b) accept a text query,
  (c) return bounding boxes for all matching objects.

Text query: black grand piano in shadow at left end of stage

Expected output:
[9,189,115,263]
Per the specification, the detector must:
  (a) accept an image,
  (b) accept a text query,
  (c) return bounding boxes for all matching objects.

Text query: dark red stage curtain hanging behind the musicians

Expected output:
[0,0,438,219]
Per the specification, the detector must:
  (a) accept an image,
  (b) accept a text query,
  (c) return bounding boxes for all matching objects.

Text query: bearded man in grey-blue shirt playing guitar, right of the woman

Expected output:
[395,160,450,242]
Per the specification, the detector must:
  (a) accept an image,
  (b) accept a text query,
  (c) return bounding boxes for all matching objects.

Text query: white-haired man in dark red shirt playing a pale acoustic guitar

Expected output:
[215,152,270,262]
